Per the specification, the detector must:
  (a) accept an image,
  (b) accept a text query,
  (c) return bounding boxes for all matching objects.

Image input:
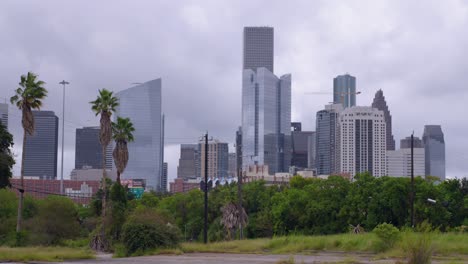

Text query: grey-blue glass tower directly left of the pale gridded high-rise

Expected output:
[315,104,343,175]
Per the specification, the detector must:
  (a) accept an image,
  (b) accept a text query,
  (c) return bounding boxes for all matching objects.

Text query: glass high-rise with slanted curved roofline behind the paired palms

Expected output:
[113,79,164,191]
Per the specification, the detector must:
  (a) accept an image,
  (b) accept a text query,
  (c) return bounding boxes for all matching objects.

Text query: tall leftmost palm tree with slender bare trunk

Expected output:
[10,72,47,232]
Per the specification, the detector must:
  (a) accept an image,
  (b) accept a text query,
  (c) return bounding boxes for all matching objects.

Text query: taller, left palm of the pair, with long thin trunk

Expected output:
[90,89,119,251]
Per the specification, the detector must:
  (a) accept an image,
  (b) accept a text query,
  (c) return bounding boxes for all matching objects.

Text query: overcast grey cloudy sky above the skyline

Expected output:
[0,0,468,184]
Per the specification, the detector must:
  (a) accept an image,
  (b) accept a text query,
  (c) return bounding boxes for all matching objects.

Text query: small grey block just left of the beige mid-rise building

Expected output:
[177,144,200,179]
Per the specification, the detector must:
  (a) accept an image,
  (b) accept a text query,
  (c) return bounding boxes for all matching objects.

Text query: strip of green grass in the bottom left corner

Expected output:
[0,247,94,262]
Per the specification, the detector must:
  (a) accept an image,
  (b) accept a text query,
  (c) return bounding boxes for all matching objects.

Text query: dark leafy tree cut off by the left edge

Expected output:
[0,122,15,189]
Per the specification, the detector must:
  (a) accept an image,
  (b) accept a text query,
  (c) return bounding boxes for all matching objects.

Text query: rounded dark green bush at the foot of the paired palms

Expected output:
[122,208,181,255]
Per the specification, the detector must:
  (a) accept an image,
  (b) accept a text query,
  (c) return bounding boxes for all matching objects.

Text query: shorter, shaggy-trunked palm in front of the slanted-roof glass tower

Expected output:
[112,116,135,184]
